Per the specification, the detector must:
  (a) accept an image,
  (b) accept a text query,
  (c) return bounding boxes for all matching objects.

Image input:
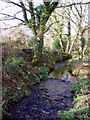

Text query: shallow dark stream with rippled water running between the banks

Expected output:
[5,61,74,120]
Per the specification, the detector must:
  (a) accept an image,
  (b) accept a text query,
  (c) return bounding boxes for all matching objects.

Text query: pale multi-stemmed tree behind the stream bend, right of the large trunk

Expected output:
[45,7,72,53]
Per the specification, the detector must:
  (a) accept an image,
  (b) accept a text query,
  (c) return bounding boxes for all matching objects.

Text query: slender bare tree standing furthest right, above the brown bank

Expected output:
[73,0,89,60]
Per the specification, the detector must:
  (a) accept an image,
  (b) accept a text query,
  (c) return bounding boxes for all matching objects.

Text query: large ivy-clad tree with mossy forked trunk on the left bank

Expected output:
[2,0,58,61]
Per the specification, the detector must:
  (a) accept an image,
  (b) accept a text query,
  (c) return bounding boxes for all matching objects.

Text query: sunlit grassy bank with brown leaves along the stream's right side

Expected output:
[58,60,90,120]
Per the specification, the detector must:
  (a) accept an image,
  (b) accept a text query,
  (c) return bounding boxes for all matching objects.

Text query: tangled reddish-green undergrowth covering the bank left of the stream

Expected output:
[2,40,71,116]
